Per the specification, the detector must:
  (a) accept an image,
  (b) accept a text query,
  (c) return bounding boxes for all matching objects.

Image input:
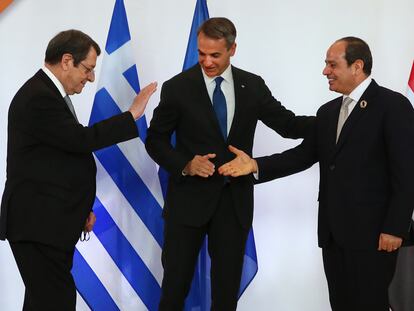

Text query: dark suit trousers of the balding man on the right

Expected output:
[322,242,398,311]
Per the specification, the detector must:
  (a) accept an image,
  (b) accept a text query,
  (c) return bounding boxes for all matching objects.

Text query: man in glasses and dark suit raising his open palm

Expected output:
[0,30,156,311]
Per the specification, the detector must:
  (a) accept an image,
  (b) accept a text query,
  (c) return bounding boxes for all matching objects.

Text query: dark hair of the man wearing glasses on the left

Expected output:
[45,29,101,66]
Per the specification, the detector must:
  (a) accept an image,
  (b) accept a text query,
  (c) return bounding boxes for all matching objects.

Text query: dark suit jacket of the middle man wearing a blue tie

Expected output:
[146,65,313,228]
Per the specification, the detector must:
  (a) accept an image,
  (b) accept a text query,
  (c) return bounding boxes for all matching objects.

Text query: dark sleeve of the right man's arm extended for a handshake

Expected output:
[256,122,318,183]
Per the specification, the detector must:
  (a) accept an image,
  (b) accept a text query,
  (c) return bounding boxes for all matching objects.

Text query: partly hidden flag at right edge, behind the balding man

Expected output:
[389,62,414,311]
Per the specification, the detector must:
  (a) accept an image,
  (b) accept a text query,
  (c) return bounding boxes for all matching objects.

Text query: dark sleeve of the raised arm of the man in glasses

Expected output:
[17,94,138,153]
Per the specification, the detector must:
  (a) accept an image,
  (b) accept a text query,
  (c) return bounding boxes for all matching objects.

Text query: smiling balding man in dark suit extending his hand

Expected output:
[219,37,414,311]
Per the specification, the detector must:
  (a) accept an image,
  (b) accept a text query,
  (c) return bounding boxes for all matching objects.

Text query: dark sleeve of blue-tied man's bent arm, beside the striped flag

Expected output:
[145,82,192,179]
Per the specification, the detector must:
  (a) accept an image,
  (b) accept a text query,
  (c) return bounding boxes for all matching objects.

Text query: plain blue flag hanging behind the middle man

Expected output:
[159,0,258,311]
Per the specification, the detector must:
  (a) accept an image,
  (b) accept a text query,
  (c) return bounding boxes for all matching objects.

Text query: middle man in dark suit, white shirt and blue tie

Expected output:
[146,18,313,311]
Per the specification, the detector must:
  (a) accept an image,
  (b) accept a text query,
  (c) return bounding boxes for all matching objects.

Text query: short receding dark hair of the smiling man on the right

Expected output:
[337,37,372,76]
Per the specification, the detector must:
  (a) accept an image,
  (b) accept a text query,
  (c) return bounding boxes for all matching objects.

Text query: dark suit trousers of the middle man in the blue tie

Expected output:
[159,185,249,311]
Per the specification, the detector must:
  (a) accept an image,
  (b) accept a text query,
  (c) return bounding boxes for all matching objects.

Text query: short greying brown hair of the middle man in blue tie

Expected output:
[197,17,237,49]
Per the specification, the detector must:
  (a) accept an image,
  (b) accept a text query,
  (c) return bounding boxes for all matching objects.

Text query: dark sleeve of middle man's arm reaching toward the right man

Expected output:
[259,78,315,138]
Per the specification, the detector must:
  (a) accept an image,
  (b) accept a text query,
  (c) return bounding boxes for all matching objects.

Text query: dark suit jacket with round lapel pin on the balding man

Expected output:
[257,81,414,249]
